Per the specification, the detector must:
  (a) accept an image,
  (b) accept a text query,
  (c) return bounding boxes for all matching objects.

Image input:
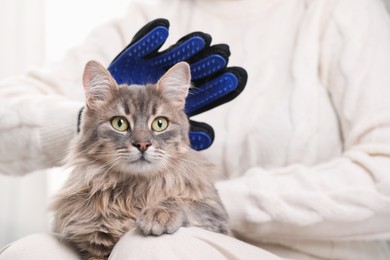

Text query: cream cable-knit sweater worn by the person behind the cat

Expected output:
[0,0,390,259]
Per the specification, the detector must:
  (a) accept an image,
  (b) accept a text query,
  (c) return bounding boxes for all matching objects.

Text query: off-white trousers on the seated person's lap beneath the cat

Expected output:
[0,228,281,260]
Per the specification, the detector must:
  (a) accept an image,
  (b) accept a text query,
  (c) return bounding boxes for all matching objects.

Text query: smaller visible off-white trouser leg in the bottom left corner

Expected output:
[0,234,80,260]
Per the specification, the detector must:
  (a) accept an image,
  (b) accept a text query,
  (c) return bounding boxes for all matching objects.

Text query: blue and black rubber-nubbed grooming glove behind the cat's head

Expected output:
[108,19,247,150]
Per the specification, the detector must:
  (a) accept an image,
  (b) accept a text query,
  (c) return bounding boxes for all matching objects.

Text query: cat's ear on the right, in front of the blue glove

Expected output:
[157,62,191,107]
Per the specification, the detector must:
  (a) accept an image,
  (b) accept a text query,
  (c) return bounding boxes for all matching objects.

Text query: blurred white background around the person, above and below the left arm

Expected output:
[0,0,390,248]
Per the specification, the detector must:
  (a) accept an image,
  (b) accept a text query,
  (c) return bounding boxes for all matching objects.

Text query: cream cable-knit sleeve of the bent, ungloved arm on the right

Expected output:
[217,0,390,242]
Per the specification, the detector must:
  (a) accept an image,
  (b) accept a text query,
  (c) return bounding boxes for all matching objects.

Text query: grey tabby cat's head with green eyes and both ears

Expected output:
[78,62,190,174]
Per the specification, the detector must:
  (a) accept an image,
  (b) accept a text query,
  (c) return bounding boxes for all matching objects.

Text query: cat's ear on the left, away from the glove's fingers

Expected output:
[83,60,118,107]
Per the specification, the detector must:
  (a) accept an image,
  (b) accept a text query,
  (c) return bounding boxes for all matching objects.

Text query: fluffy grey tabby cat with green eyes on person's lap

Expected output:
[51,61,230,260]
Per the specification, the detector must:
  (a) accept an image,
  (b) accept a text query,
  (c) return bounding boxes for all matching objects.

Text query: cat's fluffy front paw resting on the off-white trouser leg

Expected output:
[137,206,184,236]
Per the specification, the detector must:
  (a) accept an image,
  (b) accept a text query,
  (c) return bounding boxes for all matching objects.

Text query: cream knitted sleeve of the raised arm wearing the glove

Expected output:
[0,6,146,175]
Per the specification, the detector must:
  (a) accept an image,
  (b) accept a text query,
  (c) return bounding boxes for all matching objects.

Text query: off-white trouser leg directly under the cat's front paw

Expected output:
[109,227,281,260]
